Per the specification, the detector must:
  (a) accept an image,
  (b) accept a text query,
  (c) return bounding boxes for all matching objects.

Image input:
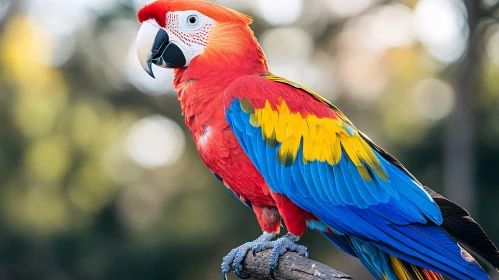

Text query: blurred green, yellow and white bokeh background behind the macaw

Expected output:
[0,0,499,280]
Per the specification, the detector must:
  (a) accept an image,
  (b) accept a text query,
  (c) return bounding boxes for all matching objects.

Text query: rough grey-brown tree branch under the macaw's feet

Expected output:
[243,249,353,280]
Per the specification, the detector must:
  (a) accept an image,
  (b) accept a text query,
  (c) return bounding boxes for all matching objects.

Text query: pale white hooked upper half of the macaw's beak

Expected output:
[136,21,169,78]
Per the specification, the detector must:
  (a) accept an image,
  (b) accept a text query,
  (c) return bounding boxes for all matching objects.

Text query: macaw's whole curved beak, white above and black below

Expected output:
[136,21,186,78]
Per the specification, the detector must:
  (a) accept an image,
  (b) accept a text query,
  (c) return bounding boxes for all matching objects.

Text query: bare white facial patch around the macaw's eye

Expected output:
[165,10,215,66]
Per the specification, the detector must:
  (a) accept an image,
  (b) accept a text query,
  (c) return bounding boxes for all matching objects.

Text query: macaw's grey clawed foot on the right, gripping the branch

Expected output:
[253,233,310,279]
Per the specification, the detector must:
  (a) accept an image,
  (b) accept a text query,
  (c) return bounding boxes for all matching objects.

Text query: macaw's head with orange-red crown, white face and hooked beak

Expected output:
[137,0,261,78]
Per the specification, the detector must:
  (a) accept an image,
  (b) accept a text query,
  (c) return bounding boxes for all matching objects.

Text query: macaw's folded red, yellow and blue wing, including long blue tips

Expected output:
[224,74,490,279]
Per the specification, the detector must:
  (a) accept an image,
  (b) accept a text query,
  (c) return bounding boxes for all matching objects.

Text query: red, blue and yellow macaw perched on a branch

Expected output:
[136,0,499,280]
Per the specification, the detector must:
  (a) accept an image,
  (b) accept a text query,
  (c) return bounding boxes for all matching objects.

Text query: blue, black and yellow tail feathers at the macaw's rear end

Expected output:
[323,188,499,280]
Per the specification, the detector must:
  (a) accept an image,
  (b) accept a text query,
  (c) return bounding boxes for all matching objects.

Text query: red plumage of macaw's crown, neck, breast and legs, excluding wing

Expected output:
[150,1,320,236]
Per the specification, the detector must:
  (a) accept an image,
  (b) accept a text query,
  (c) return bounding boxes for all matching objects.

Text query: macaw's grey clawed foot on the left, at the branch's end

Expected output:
[222,232,275,280]
